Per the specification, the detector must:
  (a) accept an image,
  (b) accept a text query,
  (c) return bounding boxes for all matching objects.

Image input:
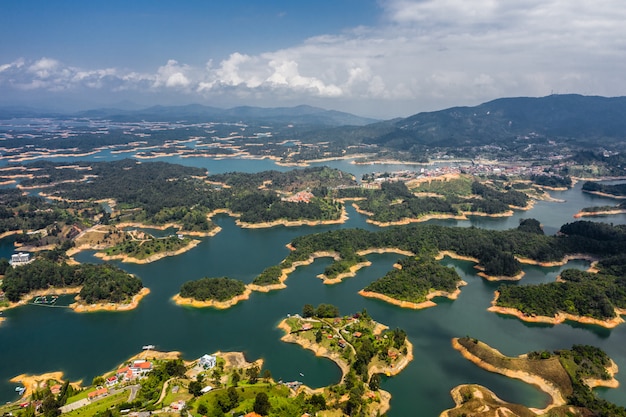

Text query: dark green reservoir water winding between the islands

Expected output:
[0,160,626,416]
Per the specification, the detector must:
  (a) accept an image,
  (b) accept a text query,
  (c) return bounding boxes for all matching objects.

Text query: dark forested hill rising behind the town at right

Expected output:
[292,94,626,151]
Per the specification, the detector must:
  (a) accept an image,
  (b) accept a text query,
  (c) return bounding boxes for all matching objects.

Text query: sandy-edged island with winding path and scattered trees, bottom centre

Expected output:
[278,304,413,416]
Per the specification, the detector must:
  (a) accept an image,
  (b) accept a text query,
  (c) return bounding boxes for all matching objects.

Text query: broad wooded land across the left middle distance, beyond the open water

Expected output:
[7,159,356,232]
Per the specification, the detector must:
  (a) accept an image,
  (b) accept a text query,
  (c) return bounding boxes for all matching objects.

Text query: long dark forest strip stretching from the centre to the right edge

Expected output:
[254,219,626,285]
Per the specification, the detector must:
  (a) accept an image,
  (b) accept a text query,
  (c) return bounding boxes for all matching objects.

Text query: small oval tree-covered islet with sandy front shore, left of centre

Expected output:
[173,277,252,309]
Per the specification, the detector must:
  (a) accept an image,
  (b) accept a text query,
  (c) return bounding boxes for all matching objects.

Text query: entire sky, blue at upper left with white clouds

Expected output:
[0,0,626,118]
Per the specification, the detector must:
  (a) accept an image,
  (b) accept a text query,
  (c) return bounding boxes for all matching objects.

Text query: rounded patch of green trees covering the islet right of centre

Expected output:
[365,257,461,303]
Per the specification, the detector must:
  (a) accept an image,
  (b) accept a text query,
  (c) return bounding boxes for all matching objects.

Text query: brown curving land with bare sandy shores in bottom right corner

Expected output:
[441,337,626,417]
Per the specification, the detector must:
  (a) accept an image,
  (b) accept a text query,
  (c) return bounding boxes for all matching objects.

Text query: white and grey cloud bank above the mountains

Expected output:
[0,0,626,117]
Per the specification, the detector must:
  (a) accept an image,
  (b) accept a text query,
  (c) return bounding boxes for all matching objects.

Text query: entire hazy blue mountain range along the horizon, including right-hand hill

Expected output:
[0,94,626,150]
